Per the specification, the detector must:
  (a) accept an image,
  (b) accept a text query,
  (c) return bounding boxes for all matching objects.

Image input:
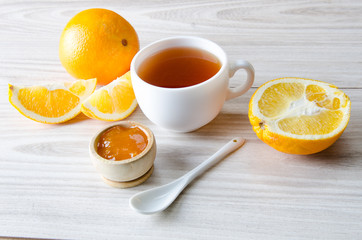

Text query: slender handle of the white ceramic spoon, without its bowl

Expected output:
[183,137,245,185]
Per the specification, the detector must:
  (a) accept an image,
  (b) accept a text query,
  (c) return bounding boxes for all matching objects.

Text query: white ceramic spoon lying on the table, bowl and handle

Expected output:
[129,137,245,214]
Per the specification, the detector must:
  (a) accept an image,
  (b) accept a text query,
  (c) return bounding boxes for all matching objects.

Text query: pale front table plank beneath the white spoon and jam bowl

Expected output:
[0,89,362,239]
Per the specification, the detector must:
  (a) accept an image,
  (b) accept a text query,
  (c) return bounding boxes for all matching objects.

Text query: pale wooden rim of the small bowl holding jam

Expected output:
[89,121,155,165]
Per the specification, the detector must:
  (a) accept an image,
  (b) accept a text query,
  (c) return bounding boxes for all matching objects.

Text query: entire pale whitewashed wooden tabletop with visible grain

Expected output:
[0,0,362,240]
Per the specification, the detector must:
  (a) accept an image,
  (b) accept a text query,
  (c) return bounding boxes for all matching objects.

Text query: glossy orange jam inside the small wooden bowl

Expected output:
[97,126,148,161]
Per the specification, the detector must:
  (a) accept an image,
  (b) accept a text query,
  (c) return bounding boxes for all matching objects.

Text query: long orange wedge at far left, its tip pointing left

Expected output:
[9,79,97,123]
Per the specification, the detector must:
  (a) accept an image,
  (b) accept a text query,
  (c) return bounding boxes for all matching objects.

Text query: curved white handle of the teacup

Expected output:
[226,60,255,100]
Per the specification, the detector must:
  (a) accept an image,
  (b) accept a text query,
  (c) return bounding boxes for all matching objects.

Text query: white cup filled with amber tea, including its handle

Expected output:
[131,37,254,132]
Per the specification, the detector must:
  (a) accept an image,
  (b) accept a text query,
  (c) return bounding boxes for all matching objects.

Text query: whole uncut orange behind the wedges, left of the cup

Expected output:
[59,8,139,85]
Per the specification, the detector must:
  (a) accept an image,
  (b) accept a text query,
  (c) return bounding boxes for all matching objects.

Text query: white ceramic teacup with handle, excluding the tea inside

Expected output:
[131,36,254,132]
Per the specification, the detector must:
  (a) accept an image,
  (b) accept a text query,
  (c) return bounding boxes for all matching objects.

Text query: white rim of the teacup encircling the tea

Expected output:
[131,36,228,91]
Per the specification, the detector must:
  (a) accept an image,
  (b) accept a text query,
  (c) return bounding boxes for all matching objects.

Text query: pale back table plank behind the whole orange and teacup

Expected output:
[0,0,362,88]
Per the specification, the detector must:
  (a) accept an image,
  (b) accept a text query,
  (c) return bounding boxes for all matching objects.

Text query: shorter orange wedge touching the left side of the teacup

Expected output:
[81,72,137,121]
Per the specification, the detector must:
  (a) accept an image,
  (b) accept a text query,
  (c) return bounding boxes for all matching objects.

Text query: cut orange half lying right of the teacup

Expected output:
[249,78,351,154]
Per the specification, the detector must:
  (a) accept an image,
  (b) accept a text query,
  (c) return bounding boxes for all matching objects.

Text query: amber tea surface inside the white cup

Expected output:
[138,47,221,88]
